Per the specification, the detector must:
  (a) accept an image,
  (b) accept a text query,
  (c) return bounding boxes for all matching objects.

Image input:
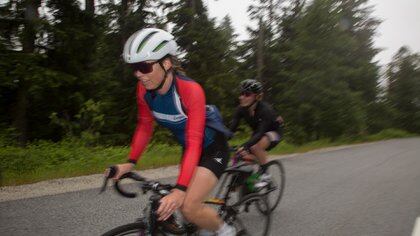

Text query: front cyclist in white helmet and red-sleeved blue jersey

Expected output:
[114,28,235,235]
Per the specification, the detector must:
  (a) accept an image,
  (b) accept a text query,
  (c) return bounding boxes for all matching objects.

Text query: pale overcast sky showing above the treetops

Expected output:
[203,0,420,65]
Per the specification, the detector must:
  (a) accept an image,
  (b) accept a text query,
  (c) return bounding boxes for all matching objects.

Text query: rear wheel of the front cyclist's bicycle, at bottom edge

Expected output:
[222,193,271,236]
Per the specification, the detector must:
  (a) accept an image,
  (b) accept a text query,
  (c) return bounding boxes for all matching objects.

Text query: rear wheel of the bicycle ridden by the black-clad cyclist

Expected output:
[258,160,286,212]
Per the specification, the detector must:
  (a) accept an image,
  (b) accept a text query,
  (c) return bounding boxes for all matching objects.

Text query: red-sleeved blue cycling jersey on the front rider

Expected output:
[130,75,228,191]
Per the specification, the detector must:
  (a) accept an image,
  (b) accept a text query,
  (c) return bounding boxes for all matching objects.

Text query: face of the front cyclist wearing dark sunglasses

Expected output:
[130,59,170,90]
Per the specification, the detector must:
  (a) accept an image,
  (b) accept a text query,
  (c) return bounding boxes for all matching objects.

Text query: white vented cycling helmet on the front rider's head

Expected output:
[123,28,178,63]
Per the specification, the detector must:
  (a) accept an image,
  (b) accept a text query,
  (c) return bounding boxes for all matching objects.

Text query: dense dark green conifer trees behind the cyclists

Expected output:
[0,0,420,149]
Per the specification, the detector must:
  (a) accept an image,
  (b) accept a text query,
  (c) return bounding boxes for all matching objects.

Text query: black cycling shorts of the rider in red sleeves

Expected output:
[198,132,229,178]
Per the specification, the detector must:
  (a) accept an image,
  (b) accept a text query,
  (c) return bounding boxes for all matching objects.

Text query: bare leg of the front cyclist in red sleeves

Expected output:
[181,166,223,231]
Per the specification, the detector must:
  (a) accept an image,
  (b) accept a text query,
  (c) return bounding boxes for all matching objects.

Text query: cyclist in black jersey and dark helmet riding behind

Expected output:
[230,79,283,183]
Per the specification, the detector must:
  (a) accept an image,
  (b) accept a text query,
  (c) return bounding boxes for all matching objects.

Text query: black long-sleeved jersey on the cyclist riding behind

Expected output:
[230,101,281,149]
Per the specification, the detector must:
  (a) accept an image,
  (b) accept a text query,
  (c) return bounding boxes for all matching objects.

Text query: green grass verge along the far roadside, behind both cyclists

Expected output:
[0,129,415,186]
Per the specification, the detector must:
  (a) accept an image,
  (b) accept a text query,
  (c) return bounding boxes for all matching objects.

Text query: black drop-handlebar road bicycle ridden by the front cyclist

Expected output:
[101,167,271,236]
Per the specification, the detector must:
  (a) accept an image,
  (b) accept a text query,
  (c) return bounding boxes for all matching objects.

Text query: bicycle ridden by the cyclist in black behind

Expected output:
[215,146,286,212]
